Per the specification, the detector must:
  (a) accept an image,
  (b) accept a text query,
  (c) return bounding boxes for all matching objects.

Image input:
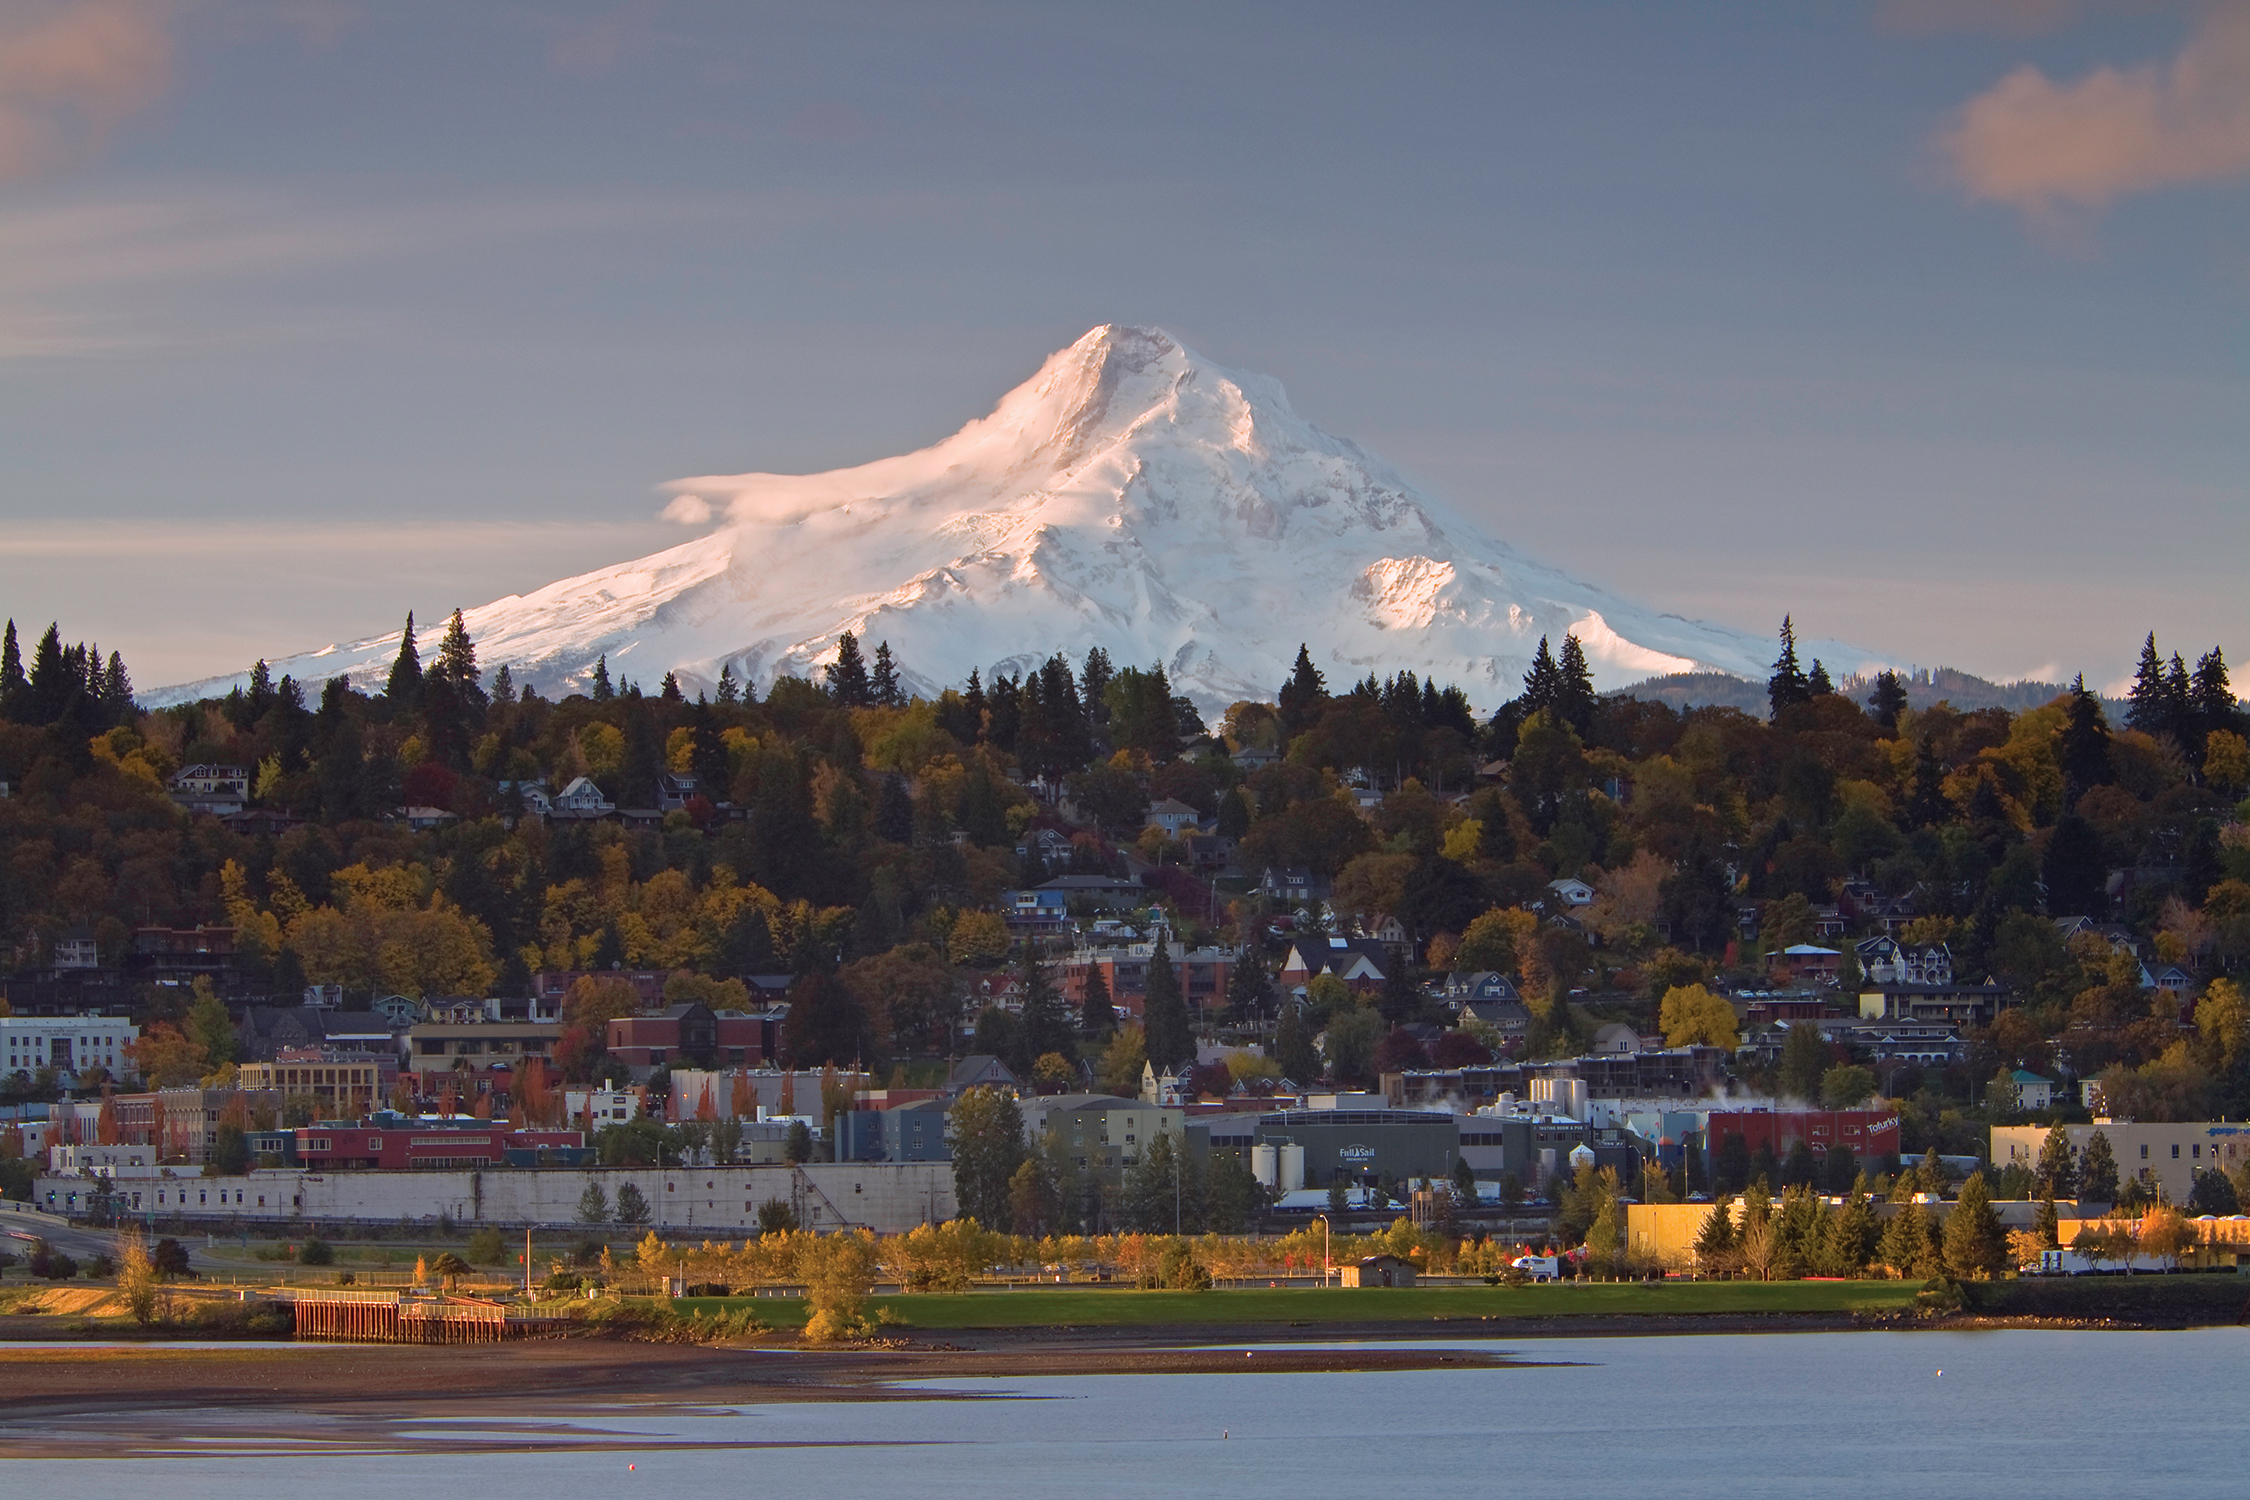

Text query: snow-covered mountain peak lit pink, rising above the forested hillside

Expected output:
[158,326,1874,713]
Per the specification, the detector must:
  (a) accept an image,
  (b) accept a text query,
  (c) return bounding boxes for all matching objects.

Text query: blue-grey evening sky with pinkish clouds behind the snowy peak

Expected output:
[0,0,2250,684]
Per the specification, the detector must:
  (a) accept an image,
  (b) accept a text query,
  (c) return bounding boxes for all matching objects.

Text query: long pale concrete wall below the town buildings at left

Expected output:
[34,1163,954,1239]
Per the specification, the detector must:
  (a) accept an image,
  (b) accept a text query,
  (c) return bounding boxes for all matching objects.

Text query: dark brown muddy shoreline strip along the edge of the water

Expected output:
[0,1311,2232,1430]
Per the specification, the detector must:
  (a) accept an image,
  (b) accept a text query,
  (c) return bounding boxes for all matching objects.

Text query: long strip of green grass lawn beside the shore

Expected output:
[677,1282,1922,1334]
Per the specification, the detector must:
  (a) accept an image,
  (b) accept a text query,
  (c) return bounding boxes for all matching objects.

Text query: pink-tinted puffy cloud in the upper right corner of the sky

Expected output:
[1937,4,2250,214]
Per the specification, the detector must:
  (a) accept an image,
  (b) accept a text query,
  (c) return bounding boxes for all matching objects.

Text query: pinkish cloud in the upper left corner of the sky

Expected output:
[0,0,171,180]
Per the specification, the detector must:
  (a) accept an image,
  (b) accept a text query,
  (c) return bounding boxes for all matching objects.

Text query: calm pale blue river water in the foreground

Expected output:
[7,1329,2250,1500]
